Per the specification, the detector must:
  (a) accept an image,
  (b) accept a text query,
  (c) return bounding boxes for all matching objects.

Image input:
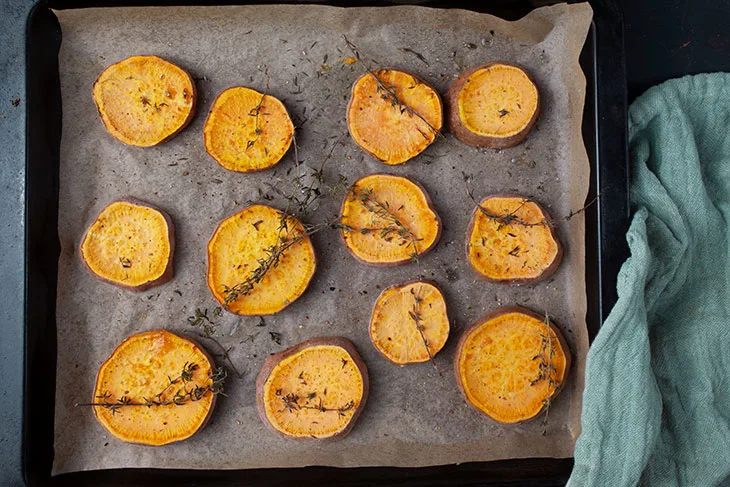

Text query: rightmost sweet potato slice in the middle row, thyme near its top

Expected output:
[466,195,563,284]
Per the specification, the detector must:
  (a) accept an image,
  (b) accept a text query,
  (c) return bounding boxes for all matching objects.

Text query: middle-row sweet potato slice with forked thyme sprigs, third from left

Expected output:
[340,174,441,266]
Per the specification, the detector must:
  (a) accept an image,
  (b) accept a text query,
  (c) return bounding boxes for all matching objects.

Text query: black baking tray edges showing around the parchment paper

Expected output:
[22,0,629,486]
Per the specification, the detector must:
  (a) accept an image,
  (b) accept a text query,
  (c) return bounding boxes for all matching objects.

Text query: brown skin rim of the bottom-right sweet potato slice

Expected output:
[454,306,573,424]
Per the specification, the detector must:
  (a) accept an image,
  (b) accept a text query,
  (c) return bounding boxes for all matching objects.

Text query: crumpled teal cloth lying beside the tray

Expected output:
[568,73,730,487]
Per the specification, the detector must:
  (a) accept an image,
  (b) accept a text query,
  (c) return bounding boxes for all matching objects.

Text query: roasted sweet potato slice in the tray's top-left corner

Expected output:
[93,56,196,147]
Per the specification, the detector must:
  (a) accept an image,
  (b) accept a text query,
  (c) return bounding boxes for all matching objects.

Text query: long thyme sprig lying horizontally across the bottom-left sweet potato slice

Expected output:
[74,362,227,415]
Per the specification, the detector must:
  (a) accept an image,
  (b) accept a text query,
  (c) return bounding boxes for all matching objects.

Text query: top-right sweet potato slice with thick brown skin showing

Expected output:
[446,63,540,149]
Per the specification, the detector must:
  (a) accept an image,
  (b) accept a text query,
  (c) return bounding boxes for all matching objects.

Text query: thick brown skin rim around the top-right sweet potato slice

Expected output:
[446,61,540,149]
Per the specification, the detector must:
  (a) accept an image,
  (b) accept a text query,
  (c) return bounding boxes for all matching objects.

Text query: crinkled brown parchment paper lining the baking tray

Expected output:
[54,4,591,474]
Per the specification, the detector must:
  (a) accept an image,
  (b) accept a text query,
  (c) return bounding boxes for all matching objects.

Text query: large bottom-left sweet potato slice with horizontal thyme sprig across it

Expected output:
[92,330,221,446]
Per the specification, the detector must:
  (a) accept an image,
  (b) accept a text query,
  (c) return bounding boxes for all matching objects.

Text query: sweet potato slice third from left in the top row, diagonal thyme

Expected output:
[347,69,443,165]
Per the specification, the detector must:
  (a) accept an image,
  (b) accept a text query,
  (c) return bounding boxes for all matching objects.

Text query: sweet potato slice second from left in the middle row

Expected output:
[208,205,317,315]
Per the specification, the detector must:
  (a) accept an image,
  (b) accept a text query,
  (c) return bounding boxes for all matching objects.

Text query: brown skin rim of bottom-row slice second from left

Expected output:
[256,337,370,443]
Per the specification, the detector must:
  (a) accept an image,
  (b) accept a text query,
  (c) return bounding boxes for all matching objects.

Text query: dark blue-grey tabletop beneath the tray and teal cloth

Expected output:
[0,0,730,486]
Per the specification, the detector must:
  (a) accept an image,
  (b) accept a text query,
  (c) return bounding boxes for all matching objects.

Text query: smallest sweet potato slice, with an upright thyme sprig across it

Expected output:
[370,281,449,365]
